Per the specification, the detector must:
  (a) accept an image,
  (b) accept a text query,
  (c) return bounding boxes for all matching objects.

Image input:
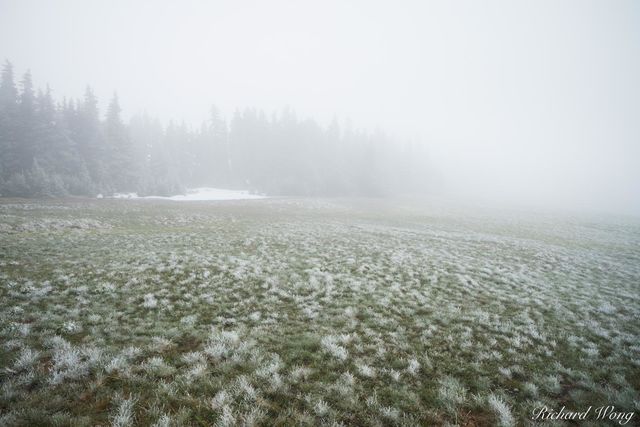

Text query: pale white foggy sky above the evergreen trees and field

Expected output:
[0,0,640,213]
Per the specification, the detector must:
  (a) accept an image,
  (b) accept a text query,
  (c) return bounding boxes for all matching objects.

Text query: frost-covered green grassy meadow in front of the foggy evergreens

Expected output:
[0,199,640,426]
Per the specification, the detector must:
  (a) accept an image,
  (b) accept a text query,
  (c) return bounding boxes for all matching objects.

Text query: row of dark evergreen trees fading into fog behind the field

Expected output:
[0,61,427,197]
